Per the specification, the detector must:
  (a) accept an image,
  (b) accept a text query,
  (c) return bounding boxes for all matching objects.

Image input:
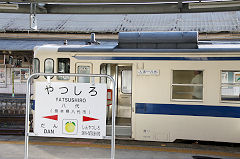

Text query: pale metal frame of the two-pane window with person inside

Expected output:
[170,69,205,102]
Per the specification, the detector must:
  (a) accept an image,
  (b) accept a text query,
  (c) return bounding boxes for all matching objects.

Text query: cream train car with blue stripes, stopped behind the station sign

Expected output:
[34,32,240,143]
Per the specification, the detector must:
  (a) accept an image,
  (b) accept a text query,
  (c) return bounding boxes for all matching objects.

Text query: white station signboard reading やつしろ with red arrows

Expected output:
[34,82,107,139]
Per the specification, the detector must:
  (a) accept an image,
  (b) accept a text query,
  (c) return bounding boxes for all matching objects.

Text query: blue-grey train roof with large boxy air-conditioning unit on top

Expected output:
[58,31,240,52]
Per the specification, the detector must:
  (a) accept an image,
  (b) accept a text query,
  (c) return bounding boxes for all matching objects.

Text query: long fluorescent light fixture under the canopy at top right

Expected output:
[188,2,240,9]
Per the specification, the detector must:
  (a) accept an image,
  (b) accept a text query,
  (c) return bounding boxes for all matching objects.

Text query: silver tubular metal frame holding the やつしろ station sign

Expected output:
[24,73,116,159]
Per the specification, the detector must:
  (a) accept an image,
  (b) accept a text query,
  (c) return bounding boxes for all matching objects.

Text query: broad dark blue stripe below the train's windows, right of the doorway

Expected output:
[136,103,240,118]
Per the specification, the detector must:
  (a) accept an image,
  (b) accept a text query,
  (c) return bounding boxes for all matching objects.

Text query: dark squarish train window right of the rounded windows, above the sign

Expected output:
[57,58,70,80]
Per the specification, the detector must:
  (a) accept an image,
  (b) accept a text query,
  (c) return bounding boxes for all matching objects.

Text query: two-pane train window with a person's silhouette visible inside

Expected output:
[172,70,203,100]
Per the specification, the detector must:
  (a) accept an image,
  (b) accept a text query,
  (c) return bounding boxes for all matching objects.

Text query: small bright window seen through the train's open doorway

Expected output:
[121,70,132,93]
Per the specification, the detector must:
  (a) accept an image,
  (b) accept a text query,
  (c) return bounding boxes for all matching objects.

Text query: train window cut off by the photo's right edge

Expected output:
[221,71,240,101]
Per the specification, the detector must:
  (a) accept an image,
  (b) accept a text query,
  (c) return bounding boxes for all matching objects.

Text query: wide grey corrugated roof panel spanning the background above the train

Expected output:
[0,11,240,33]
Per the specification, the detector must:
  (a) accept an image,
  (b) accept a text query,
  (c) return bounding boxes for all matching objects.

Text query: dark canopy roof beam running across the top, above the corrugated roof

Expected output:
[0,0,240,14]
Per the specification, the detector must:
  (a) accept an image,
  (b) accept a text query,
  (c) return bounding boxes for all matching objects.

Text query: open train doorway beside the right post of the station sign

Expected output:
[101,64,132,137]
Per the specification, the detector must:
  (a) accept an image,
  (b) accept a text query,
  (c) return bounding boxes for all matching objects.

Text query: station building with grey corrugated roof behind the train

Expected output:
[0,11,240,96]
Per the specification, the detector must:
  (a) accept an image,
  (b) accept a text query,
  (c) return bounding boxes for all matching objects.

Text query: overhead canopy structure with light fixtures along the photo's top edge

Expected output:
[0,0,240,14]
